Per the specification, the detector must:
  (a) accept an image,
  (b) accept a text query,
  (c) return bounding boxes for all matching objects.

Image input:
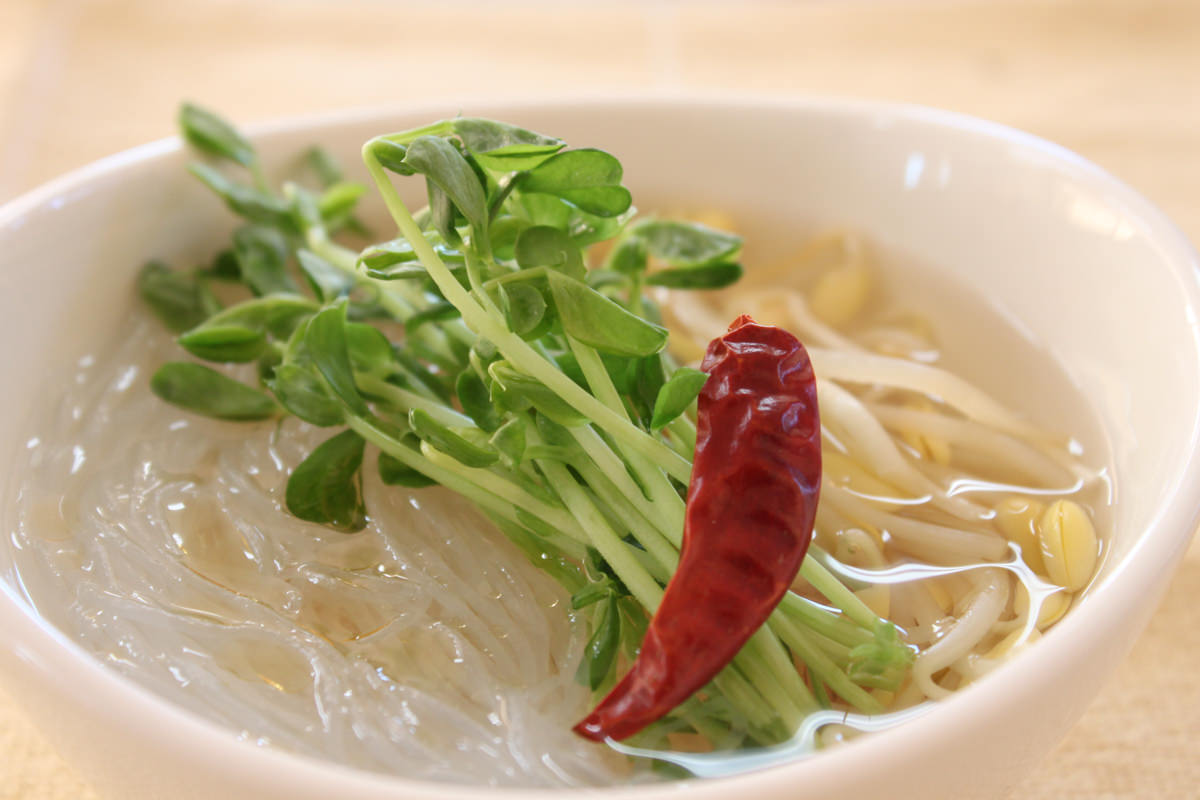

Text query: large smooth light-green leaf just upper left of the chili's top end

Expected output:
[546,272,667,356]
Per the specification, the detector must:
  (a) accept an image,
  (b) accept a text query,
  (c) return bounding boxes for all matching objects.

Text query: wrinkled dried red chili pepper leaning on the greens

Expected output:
[575,315,821,741]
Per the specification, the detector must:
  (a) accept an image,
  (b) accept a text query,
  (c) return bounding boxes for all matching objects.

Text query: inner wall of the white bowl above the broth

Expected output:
[0,101,1200,796]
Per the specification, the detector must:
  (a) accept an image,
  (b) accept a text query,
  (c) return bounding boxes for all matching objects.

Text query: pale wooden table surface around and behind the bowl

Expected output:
[0,0,1200,800]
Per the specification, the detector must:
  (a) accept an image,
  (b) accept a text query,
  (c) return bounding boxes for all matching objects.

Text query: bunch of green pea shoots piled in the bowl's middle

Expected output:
[145,106,912,747]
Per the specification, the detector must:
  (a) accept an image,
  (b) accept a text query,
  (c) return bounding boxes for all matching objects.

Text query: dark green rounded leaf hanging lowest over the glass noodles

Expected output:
[287,431,367,533]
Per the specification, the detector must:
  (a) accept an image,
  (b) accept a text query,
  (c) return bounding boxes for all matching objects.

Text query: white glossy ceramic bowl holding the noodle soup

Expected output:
[0,98,1200,800]
